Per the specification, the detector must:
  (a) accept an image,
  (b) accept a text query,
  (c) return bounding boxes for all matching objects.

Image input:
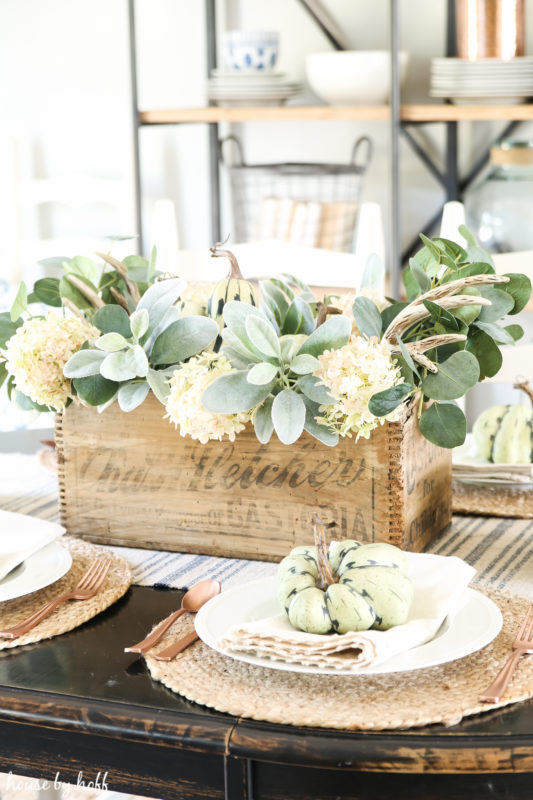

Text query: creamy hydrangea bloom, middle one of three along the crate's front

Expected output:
[166,352,251,444]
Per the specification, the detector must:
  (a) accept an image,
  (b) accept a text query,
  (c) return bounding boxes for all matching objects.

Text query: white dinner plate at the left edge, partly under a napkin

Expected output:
[0,542,72,602]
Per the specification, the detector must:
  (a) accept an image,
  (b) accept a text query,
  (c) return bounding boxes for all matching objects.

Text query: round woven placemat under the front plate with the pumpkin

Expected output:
[145,587,533,730]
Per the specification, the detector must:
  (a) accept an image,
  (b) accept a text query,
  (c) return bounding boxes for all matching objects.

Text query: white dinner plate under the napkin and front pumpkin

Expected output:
[195,576,502,677]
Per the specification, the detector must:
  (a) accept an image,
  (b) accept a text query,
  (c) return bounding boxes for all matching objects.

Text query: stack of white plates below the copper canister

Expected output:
[430,56,533,104]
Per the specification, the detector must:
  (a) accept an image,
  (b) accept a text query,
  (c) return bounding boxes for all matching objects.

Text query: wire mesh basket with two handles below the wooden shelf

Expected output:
[219,136,372,252]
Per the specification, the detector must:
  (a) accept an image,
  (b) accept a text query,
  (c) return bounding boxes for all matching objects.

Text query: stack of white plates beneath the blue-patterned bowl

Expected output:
[207,69,303,106]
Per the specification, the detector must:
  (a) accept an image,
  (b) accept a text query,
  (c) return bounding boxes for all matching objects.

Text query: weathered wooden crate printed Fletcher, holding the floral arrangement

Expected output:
[56,396,451,560]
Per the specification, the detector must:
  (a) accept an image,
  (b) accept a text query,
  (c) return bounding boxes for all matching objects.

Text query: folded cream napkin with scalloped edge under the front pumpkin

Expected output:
[217,553,476,672]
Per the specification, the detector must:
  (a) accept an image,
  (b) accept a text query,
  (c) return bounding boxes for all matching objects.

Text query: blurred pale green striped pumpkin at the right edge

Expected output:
[472,403,533,464]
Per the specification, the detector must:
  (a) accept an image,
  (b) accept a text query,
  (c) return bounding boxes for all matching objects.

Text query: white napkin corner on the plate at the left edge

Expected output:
[0,509,65,581]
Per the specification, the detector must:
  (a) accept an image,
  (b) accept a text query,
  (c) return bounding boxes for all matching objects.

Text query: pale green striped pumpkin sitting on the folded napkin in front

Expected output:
[278,530,413,634]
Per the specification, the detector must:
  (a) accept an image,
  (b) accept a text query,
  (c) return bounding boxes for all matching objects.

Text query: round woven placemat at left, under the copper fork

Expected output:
[0,537,131,650]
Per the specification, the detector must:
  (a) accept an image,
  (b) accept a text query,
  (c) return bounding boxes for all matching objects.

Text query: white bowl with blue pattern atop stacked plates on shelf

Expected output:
[222,30,279,72]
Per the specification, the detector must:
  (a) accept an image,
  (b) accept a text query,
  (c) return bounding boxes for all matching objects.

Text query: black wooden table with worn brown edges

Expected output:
[0,587,533,800]
